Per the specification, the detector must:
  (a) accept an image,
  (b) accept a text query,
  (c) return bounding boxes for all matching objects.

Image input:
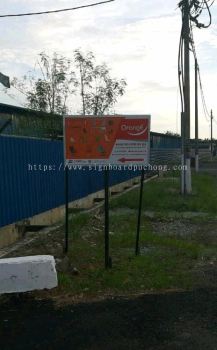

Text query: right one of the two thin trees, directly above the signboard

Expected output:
[74,50,127,115]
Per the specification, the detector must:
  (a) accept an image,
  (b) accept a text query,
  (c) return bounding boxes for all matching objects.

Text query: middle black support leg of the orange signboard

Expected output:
[104,169,112,269]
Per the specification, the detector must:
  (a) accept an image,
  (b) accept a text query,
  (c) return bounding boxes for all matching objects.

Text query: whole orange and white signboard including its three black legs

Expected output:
[64,115,150,262]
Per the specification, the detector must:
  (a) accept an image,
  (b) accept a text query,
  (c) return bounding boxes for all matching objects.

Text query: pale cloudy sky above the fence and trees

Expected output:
[0,0,217,137]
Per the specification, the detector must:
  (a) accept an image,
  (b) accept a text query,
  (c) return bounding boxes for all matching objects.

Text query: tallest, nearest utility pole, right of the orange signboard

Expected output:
[182,0,191,194]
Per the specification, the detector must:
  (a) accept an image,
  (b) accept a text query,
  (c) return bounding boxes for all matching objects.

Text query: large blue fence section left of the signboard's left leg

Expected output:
[0,136,64,226]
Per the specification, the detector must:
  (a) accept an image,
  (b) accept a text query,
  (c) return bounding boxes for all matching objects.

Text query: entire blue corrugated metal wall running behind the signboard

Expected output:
[0,133,180,227]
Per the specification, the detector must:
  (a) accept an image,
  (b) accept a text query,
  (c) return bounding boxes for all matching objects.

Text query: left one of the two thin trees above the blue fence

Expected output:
[12,52,77,114]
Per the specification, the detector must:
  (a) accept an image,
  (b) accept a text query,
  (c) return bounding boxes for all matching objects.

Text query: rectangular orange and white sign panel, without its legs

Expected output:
[64,115,150,165]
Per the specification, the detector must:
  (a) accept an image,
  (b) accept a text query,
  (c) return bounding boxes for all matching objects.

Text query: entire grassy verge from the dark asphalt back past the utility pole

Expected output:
[56,174,217,296]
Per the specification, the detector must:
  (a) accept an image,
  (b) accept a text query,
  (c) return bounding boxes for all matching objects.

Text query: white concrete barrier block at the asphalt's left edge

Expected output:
[0,255,58,294]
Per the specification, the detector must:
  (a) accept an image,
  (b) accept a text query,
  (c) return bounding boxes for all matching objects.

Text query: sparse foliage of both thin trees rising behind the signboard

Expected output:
[9,50,126,115]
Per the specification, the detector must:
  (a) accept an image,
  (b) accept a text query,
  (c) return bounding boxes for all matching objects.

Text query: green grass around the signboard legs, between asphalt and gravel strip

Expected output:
[55,214,212,295]
